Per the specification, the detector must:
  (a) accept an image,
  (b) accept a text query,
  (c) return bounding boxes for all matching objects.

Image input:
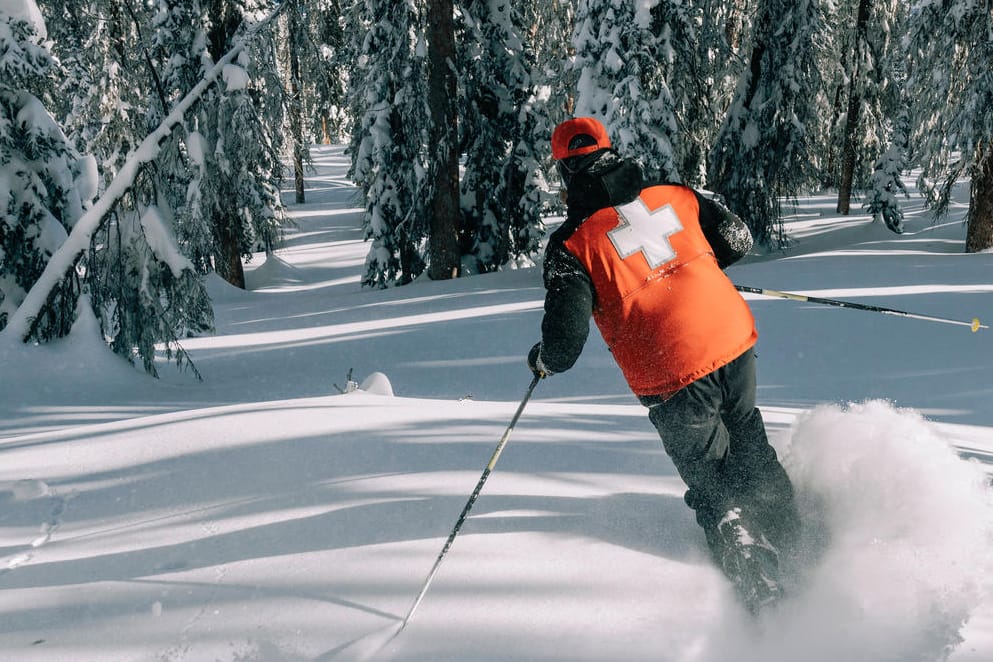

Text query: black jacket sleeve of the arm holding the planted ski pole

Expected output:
[539,236,593,373]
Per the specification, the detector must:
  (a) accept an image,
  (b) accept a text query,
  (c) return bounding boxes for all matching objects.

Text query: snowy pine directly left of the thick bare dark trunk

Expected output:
[350,0,428,287]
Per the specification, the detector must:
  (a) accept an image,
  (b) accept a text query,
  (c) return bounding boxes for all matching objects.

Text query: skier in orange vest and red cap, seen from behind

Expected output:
[528,117,799,613]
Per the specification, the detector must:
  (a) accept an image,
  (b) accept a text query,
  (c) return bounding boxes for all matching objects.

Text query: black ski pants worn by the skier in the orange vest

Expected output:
[641,349,799,559]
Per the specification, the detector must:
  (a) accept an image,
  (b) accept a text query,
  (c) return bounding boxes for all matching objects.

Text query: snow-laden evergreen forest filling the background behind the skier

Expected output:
[0,0,993,373]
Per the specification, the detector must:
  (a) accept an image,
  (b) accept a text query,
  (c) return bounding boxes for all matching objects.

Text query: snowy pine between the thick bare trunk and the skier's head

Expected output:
[459,0,547,273]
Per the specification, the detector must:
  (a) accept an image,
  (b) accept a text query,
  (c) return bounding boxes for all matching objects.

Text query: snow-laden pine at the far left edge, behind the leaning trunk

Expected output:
[0,0,96,341]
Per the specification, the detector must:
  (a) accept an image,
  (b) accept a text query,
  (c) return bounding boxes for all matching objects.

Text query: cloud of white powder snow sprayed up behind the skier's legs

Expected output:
[707,401,993,662]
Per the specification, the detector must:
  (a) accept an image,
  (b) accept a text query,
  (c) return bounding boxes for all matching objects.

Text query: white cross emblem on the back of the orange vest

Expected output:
[607,198,683,269]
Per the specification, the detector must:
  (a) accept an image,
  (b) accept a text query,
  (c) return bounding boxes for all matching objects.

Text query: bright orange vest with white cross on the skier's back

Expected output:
[565,185,758,397]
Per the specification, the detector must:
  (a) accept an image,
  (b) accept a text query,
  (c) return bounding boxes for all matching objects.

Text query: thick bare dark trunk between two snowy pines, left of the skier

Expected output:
[427,0,460,280]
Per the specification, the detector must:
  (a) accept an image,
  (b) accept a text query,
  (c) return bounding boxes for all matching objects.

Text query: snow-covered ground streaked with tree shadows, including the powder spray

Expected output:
[0,147,993,662]
